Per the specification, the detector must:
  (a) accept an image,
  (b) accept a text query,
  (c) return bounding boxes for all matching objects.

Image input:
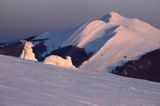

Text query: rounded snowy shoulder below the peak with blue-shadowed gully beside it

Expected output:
[63,20,116,52]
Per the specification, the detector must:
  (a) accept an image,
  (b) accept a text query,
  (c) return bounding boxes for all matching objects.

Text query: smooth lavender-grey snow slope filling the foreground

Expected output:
[0,55,160,106]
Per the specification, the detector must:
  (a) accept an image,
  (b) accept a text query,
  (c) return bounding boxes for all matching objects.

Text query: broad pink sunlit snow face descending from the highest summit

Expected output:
[81,13,160,72]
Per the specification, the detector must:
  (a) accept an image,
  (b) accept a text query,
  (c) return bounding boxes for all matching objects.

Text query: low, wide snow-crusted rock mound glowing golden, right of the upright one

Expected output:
[43,55,75,68]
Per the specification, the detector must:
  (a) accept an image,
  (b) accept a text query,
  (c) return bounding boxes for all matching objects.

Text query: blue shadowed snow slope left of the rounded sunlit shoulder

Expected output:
[31,27,77,57]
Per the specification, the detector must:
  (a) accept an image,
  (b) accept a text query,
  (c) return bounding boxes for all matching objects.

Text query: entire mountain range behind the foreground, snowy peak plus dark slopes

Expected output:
[0,12,160,81]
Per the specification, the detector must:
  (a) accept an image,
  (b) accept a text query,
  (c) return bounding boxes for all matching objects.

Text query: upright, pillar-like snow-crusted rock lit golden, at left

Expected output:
[20,40,37,61]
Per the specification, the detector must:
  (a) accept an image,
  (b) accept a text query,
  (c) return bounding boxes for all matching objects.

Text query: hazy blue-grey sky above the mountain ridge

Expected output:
[0,0,160,42]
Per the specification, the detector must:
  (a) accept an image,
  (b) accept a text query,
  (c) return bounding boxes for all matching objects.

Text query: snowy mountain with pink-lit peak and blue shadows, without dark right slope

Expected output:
[0,12,160,72]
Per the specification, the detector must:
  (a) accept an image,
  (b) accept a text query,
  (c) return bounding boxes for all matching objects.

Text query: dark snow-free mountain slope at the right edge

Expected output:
[113,49,160,82]
